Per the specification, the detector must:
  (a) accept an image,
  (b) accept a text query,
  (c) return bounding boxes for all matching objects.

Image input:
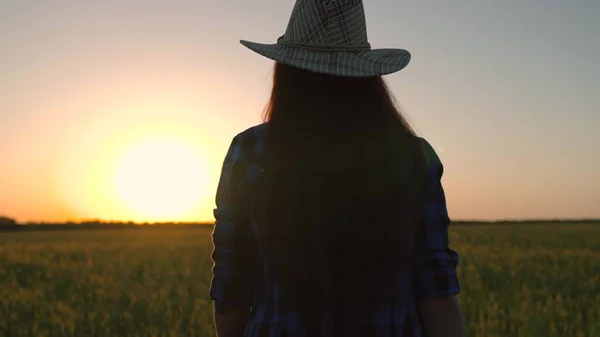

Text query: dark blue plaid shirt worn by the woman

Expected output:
[210,124,459,337]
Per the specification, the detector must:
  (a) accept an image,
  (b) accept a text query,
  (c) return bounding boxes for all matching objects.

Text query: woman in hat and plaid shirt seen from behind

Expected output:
[210,0,464,337]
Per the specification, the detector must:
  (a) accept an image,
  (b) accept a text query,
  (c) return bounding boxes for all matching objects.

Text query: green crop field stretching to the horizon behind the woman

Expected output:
[0,224,600,337]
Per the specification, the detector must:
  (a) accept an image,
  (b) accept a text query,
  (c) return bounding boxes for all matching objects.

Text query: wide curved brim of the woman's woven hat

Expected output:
[240,40,411,77]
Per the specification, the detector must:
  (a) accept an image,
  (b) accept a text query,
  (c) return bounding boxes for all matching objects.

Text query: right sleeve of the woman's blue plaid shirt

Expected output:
[414,140,460,298]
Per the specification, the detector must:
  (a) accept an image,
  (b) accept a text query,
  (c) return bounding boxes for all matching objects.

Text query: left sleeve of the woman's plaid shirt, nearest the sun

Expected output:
[209,135,258,312]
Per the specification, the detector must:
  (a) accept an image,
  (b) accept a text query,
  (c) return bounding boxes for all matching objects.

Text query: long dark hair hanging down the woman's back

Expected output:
[258,63,423,329]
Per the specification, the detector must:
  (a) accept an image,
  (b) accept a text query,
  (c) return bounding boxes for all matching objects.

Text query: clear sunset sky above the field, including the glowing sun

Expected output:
[0,0,600,221]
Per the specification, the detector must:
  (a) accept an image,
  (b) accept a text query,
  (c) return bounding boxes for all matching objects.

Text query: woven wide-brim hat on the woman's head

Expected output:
[240,0,410,77]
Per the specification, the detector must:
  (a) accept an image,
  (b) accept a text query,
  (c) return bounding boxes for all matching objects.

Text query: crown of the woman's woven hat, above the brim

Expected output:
[279,0,370,49]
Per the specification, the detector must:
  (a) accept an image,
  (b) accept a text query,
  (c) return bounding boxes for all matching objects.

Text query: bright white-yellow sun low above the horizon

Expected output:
[113,138,206,221]
